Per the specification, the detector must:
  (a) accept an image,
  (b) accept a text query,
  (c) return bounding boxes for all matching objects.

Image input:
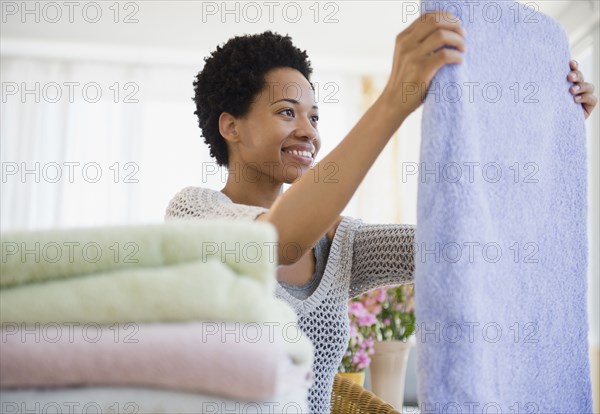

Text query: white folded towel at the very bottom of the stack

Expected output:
[0,387,309,414]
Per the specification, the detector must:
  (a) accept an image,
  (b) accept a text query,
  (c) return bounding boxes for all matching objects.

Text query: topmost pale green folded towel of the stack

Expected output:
[0,220,277,291]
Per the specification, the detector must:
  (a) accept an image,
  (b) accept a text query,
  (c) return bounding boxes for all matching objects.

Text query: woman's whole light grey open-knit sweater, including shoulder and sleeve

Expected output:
[165,187,415,414]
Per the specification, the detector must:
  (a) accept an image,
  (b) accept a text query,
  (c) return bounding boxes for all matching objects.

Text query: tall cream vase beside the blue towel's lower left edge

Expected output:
[369,336,415,412]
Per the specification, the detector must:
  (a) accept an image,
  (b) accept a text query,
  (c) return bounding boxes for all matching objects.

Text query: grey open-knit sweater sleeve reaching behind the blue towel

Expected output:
[349,224,416,298]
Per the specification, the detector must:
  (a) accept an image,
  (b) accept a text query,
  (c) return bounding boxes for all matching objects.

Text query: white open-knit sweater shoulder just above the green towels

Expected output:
[165,187,269,221]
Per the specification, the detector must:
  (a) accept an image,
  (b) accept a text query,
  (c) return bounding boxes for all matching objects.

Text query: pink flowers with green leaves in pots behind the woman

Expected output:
[339,284,415,372]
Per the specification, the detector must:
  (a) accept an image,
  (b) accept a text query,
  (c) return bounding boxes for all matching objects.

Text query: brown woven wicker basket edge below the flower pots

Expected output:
[331,374,400,414]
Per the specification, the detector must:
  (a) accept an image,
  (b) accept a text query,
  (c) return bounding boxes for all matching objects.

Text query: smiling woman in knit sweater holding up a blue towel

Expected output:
[167,12,597,413]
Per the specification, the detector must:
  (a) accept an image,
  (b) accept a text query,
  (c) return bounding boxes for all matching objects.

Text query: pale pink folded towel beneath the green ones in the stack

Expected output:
[0,322,311,400]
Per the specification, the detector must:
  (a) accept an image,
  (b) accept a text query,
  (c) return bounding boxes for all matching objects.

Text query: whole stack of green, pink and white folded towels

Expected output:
[0,220,313,413]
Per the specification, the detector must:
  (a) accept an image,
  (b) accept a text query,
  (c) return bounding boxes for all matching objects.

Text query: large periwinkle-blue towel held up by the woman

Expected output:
[415,1,592,413]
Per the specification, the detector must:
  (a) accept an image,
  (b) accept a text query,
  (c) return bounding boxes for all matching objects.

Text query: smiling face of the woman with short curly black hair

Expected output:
[229,68,321,184]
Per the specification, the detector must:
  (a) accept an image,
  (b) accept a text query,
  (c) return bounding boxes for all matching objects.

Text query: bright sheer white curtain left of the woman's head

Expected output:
[0,56,210,230]
